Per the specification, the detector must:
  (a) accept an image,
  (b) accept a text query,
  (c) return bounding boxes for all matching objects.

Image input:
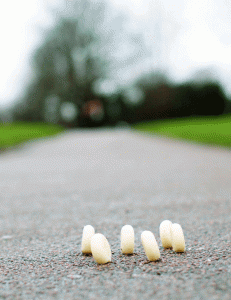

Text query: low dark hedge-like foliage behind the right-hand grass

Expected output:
[127,73,229,123]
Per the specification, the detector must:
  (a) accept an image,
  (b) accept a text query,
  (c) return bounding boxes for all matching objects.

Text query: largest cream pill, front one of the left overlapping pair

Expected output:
[91,233,111,264]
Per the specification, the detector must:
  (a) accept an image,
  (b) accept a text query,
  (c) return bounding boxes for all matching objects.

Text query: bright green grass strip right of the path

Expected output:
[133,115,231,147]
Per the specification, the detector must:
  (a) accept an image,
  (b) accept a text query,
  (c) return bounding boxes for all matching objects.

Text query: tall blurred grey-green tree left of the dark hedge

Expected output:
[17,0,148,122]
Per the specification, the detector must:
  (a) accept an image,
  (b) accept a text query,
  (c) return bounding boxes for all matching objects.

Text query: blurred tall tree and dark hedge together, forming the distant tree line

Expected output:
[10,0,231,127]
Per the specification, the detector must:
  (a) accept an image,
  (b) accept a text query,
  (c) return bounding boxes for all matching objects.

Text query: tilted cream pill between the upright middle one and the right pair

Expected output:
[141,231,160,261]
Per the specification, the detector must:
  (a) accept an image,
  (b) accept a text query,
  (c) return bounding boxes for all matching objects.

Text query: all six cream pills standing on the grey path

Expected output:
[81,220,185,264]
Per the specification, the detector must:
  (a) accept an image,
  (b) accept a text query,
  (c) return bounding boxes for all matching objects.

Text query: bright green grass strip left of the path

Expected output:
[0,122,64,150]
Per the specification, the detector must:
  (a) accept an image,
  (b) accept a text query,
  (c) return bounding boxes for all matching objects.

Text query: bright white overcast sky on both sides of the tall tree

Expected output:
[0,0,231,106]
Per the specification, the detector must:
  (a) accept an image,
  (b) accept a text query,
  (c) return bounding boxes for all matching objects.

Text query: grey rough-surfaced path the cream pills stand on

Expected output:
[0,129,231,300]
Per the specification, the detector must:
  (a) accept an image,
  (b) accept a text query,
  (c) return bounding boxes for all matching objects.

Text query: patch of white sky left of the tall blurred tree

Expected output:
[0,0,53,107]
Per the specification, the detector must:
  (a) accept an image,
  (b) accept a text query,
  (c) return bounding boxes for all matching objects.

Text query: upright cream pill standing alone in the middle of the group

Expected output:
[121,225,135,254]
